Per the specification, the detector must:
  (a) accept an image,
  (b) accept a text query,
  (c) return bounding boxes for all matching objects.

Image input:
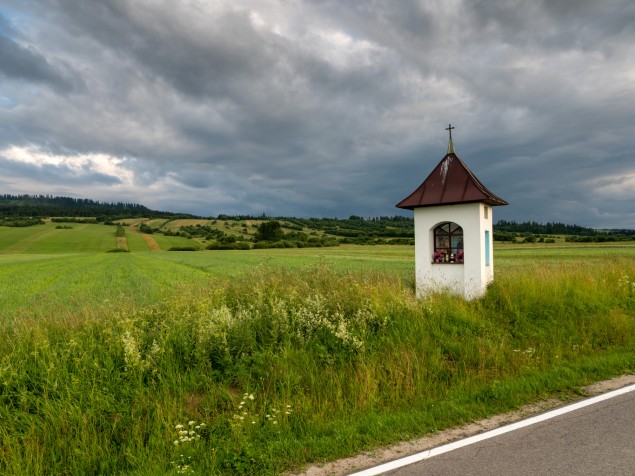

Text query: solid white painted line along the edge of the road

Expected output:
[350,385,635,476]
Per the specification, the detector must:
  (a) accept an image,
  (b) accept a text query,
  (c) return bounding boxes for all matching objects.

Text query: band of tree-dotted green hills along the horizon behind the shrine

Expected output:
[0,194,635,252]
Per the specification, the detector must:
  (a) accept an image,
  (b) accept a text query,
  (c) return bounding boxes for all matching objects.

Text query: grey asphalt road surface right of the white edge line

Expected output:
[360,391,635,476]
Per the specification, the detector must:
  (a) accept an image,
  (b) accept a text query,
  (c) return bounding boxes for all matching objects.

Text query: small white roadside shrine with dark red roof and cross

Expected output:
[396,125,508,300]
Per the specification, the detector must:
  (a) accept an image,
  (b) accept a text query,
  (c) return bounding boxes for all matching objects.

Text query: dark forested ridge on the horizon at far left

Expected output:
[0,194,194,221]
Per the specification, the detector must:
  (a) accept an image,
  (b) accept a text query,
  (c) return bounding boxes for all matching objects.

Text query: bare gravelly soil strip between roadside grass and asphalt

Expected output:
[295,375,635,476]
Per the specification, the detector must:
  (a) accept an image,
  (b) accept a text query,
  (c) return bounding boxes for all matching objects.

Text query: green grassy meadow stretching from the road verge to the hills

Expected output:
[0,224,635,475]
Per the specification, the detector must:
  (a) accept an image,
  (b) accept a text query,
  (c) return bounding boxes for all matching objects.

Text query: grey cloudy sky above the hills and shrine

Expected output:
[0,0,635,228]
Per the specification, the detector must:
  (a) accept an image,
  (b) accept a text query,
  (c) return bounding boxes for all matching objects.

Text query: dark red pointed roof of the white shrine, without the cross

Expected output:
[396,149,508,210]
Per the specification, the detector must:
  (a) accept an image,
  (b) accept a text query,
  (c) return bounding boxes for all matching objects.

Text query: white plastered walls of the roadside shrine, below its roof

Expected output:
[414,203,494,299]
